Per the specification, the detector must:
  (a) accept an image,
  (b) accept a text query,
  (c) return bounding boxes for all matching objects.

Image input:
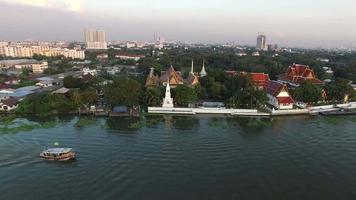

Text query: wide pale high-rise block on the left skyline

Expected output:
[84,29,108,49]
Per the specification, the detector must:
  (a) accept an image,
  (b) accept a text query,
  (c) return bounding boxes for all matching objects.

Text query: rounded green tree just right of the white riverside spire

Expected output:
[174,85,198,106]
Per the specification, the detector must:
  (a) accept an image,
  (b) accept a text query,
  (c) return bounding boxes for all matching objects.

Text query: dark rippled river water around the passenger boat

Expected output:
[0,116,356,200]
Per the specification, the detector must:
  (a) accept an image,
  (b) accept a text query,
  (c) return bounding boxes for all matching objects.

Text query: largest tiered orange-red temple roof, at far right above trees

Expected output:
[278,64,323,87]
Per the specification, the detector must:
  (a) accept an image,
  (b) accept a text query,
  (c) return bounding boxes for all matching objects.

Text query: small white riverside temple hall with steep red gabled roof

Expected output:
[266,81,294,110]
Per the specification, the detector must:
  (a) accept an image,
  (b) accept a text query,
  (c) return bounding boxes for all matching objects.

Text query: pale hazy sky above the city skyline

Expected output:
[0,0,356,48]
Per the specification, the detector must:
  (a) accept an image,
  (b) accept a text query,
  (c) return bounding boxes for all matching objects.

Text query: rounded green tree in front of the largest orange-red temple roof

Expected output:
[293,81,322,103]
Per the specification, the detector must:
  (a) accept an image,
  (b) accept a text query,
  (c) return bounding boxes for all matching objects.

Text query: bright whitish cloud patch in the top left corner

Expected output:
[0,0,83,12]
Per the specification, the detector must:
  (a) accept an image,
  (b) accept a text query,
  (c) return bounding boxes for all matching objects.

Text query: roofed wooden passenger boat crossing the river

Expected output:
[40,148,75,161]
